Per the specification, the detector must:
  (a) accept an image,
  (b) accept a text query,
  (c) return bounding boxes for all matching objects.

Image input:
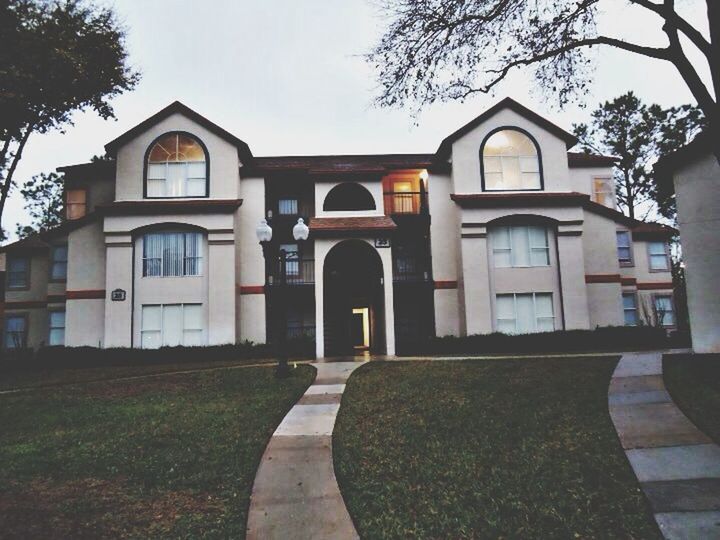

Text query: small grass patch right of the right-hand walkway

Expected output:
[663,354,720,444]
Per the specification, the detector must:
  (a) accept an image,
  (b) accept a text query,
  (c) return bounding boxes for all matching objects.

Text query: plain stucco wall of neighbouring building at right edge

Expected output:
[674,154,720,353]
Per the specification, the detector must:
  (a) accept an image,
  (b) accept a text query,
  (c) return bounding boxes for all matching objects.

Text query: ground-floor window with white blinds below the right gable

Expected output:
[496,293,555,334]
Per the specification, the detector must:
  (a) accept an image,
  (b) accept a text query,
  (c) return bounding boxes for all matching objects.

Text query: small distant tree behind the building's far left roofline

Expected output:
[15,173,65,238]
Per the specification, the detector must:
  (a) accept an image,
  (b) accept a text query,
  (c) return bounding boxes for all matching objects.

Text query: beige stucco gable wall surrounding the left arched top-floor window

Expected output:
[115,113,240,201]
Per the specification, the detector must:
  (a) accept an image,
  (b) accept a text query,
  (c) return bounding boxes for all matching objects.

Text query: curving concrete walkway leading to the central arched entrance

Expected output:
[247,362,362,540]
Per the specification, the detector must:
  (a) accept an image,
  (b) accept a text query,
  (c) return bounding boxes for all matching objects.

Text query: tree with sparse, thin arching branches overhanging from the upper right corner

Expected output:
[369,0,720,161]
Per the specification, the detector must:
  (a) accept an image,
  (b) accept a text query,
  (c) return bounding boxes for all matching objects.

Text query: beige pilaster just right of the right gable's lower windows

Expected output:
[557,230,590,330]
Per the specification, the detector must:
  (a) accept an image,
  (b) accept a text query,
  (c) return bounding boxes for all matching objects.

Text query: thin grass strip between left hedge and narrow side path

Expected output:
[0,358,282,391]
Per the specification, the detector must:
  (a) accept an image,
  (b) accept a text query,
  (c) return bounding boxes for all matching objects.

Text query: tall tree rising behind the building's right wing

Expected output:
[573,92,705,219]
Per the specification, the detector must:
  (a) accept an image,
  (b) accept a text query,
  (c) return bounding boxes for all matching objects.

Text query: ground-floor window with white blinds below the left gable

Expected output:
[140,304,204,349]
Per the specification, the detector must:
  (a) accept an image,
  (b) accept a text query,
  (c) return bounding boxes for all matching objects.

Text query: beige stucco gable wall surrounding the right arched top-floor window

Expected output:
[452,109,570,193]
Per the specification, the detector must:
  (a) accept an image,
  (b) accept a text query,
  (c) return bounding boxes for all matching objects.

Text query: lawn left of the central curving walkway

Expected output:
[0,366,315,539]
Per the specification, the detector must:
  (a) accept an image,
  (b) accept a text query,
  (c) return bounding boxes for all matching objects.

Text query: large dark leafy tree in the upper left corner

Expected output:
[0,0,139,236]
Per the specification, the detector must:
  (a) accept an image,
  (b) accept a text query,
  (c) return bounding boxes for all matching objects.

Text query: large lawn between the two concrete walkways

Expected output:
[333,357,660,538]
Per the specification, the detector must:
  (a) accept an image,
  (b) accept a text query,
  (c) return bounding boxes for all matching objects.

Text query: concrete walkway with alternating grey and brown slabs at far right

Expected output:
[608,352,720,539]
